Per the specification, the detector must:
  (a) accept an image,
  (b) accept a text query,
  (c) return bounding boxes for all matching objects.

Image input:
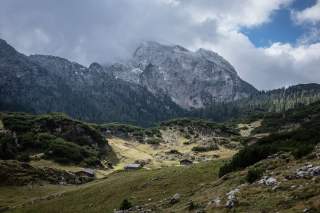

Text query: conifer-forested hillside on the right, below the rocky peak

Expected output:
[190,84,320,122]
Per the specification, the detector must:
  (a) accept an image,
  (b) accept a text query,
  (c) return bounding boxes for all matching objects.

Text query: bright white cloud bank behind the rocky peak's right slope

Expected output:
[191,28,320,89]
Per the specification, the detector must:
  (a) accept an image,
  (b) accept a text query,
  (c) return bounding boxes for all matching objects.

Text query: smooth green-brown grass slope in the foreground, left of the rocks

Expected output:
[7,161,221,213]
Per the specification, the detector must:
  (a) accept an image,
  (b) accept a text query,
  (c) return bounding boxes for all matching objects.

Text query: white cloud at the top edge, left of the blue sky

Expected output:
[180,0,293,29]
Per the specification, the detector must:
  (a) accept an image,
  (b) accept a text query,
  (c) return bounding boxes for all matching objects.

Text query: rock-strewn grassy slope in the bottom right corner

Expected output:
[190,156,320,213]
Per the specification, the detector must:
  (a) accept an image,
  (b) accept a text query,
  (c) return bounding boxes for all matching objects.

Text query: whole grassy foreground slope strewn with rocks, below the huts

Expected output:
[0,155,320,213]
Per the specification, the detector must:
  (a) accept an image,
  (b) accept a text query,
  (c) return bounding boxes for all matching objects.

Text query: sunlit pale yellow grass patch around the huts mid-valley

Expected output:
[108,134,236,170]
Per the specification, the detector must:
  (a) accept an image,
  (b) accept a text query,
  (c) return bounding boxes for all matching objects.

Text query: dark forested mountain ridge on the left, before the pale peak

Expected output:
[0,40,183,125]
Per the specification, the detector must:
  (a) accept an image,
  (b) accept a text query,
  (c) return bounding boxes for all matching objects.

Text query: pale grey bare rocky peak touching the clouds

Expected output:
[107,42,257,109]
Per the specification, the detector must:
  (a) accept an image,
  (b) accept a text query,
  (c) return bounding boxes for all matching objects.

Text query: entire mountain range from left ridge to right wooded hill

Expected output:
[0,37,320,126]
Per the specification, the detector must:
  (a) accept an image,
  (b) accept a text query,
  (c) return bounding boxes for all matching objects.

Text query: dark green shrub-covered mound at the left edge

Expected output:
[0,113,107,166]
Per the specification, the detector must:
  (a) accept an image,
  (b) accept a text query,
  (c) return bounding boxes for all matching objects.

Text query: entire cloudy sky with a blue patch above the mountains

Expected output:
[0,0,320,90]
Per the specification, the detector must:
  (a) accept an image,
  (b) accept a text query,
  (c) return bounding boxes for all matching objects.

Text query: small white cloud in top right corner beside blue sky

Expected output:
[292,0,320,24]
